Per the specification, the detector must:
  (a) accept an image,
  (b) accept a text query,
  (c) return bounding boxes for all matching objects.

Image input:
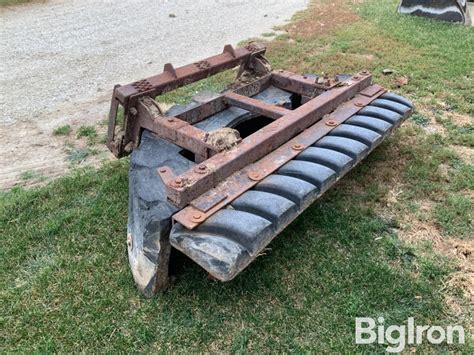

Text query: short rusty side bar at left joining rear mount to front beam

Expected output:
[137,97,217,158]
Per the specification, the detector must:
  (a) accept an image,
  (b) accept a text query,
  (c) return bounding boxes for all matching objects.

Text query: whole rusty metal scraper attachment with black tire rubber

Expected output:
[107,43,412,293]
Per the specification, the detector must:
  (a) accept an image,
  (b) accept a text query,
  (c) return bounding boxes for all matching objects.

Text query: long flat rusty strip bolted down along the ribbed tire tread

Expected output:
[173,85,385,229]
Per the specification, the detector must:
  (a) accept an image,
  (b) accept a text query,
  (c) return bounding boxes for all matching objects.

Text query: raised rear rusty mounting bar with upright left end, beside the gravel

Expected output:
[107,43,266,157]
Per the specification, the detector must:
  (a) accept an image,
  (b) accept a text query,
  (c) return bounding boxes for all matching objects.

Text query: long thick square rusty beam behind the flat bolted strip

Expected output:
[160,73,372,207]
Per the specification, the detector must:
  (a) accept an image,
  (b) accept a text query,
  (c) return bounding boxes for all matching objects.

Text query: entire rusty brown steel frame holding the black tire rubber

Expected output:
[107,44,385,229]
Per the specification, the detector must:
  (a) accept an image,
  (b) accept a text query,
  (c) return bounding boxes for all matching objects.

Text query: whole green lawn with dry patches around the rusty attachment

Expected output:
[0,0,474,353]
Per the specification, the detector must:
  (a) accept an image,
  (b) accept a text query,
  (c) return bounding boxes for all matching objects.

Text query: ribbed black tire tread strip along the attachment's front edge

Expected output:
[170,93,413,281]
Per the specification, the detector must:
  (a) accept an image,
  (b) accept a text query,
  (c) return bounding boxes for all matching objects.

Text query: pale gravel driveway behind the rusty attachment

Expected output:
[0,0,307,188]
